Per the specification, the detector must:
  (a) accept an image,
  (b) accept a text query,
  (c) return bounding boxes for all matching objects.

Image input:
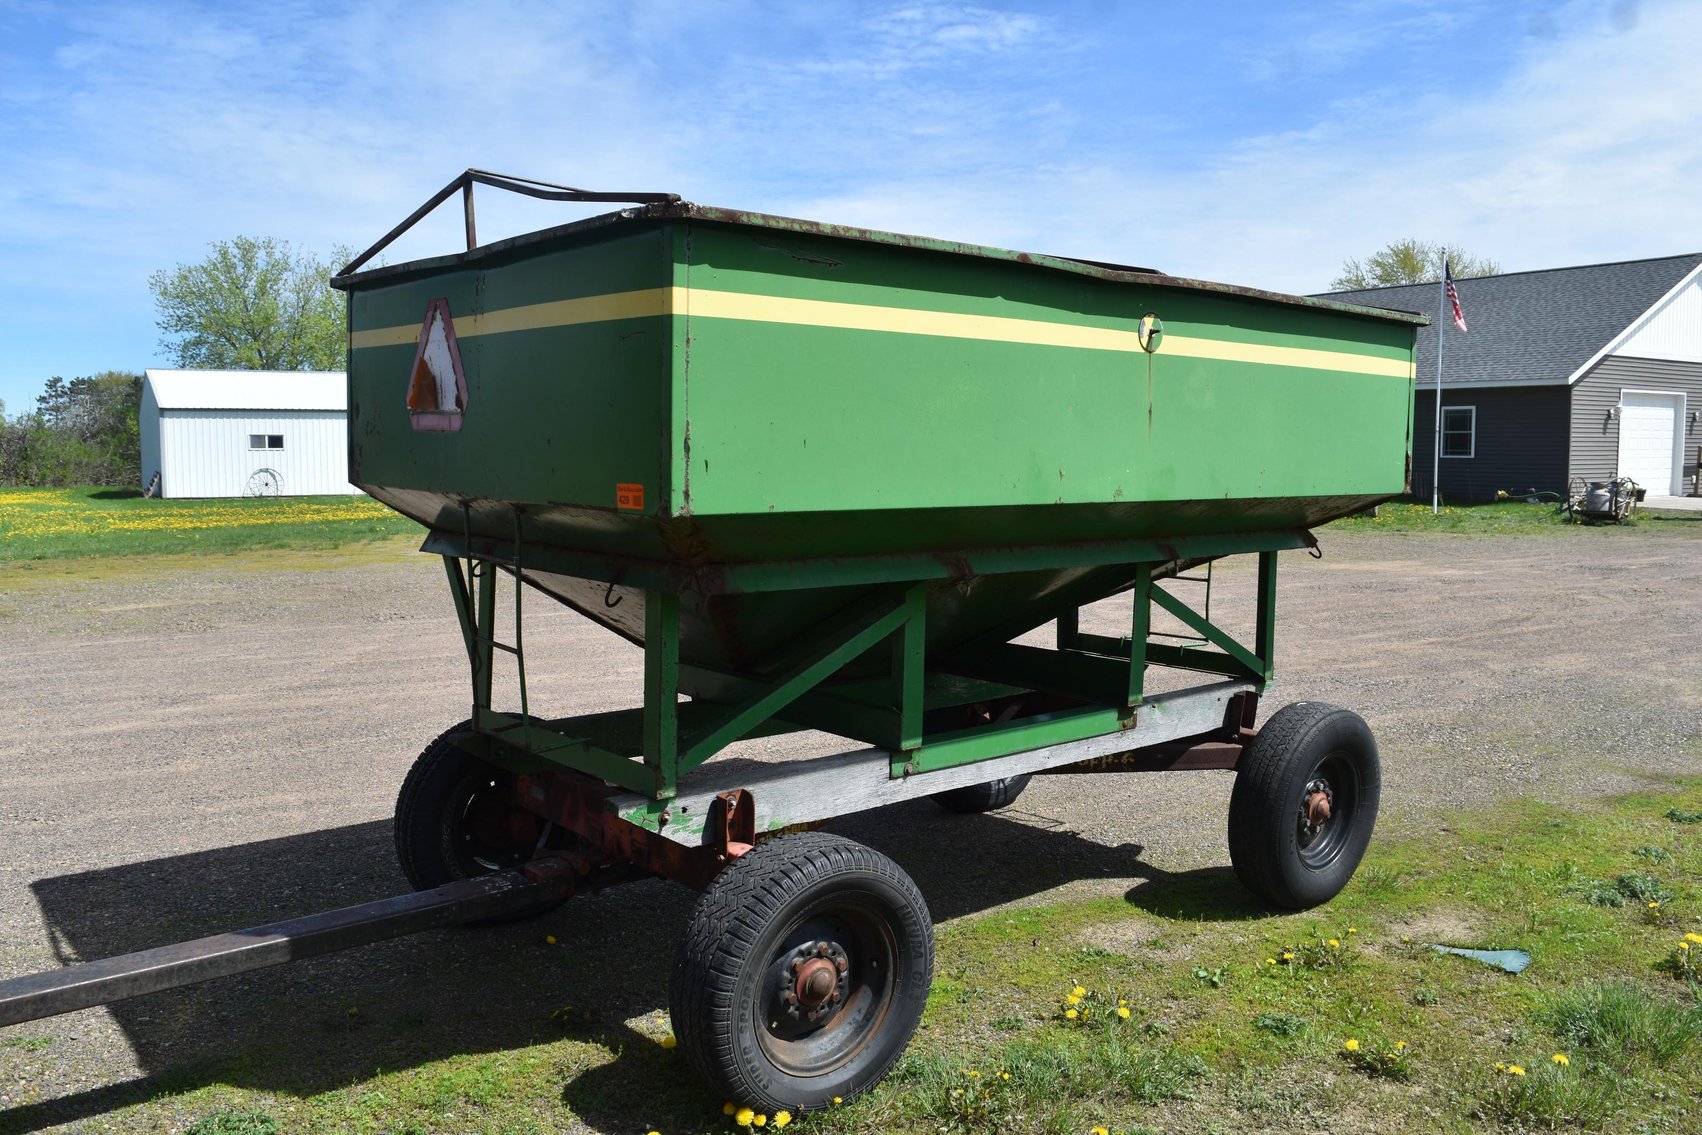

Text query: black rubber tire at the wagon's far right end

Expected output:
[1229,701,1382,910]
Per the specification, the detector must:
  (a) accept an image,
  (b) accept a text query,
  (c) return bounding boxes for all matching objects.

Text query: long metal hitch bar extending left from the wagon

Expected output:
[0,856,580,1028]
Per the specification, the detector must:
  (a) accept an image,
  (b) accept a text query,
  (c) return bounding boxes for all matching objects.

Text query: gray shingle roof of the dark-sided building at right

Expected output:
[1317,252,1702,386]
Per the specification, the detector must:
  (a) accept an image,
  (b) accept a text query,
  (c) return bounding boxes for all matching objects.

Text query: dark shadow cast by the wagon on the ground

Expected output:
[0,801,1170,1132]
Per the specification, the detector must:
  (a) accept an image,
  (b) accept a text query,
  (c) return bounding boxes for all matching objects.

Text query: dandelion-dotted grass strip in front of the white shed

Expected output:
[0,488,420,560]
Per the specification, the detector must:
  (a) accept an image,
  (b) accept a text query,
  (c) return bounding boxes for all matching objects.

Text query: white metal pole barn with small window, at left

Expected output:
[141,371,361,497]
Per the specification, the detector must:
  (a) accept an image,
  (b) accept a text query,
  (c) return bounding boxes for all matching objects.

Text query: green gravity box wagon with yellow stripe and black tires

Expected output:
[0,170,1421,1111]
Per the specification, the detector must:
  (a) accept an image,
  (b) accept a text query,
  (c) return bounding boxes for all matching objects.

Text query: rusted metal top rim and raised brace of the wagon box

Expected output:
[330,179,1430,327]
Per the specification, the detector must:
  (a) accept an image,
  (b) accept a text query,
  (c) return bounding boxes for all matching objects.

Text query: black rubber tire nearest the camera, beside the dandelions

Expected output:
[669,832,934,1115]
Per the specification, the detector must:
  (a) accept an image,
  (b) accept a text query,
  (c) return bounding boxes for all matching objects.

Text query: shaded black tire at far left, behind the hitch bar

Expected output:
[391,721,565,926]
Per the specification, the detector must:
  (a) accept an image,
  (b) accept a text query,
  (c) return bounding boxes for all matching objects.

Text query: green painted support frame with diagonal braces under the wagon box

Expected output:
[443,547,1297,813]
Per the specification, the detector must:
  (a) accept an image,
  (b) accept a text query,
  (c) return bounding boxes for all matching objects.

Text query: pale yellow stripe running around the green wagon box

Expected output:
[349,288,1413,379]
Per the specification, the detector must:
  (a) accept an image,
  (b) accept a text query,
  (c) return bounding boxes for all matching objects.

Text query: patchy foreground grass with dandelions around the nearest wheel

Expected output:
[0,781,1702,1135]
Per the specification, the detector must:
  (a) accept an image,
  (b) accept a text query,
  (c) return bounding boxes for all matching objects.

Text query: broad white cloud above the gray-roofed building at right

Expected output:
[789,3,1702,291]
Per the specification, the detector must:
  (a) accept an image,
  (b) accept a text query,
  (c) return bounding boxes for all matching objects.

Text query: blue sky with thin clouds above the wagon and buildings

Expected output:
[0,0,1702,414]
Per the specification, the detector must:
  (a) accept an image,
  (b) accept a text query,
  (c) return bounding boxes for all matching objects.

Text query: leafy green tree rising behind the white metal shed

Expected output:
[148,237,347,371]
